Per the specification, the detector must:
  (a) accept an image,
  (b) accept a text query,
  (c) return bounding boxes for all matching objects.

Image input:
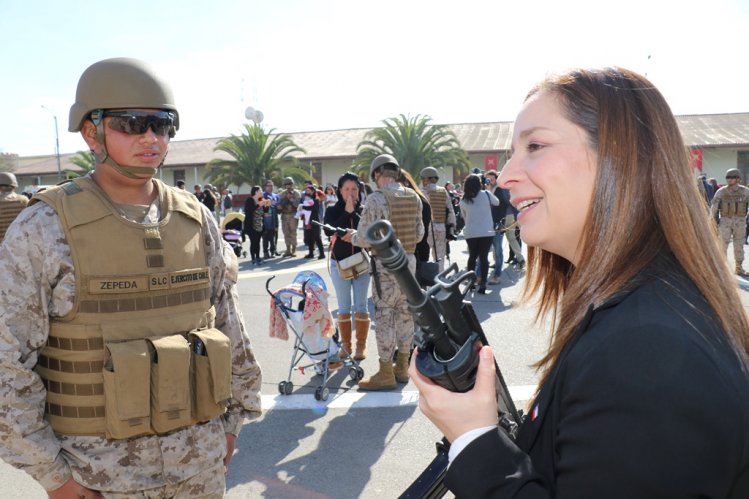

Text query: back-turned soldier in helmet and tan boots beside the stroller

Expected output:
[344,154,424,390]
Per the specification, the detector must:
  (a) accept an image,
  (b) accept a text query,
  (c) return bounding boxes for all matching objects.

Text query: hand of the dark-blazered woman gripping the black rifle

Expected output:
[408,346,499,442]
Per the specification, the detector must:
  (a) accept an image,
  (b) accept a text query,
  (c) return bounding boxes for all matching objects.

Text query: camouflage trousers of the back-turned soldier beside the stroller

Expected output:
[372,255,416,359]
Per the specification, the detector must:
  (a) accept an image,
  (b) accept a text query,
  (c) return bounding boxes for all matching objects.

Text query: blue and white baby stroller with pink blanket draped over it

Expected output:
[265,271,364,401]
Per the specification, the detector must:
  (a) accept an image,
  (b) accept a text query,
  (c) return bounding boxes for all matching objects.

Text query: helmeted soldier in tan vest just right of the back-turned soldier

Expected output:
[420,166,456,272]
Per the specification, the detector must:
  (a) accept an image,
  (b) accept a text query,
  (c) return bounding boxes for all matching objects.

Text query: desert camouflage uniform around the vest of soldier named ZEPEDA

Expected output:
[0,193,261,497]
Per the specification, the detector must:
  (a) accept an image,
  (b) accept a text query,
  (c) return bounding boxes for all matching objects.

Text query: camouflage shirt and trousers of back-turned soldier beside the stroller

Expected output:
[351,181,424,359]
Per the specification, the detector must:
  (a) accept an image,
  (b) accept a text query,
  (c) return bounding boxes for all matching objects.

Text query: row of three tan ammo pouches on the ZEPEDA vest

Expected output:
[103,329,231,439]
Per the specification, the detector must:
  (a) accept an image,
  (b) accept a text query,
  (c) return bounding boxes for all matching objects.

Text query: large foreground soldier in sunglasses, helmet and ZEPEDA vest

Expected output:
[0,58,260,498]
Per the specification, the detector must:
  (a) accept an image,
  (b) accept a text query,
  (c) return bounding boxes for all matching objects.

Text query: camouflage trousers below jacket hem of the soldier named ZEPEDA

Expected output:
[101,461,226,499]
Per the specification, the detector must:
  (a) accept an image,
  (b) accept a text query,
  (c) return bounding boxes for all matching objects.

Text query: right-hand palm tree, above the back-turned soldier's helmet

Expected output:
[354,114,470,178]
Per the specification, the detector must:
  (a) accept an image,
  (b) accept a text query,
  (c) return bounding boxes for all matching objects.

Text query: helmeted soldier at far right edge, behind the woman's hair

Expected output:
[710,168,749,276]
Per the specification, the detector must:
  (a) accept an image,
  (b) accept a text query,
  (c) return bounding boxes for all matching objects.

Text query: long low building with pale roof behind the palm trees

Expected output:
[10,113,749,192]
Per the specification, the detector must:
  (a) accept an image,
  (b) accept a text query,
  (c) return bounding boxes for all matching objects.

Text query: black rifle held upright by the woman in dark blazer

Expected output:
[365,220,521,499]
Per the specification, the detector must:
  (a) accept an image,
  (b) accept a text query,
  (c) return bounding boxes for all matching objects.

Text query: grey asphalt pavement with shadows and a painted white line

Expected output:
[0,235,749,499]
